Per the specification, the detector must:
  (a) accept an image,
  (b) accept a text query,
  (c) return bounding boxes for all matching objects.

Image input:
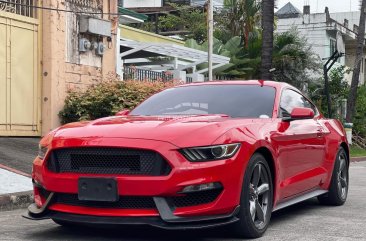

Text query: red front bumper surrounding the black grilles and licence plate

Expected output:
[25,138,247,228]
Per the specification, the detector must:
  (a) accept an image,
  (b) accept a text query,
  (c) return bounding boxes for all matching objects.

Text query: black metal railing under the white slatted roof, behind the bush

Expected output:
[123,66,174,82]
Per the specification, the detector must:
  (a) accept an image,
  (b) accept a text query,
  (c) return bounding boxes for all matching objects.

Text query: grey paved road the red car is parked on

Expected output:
[0,162,366,241]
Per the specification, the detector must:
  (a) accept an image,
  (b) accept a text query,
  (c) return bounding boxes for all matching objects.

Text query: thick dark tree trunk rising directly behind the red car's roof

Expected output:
[261,0,274,80]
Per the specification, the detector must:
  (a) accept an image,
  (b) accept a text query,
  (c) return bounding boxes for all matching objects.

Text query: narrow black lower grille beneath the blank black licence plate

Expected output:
[55,193,156,209]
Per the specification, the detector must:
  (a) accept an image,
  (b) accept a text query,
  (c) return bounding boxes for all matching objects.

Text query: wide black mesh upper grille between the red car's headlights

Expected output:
[47,147,171,176]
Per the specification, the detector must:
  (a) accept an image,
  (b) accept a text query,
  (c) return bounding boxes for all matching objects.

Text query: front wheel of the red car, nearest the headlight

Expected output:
[233,153,273,238]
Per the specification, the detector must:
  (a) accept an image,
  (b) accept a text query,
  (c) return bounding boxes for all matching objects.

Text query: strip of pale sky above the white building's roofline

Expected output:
[275,0,360,13]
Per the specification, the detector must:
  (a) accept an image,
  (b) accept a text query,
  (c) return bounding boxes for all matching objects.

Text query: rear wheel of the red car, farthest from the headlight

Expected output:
[318,147,349,206]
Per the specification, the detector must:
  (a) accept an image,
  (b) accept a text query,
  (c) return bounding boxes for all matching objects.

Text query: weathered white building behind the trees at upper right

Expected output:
[276,3,366,84]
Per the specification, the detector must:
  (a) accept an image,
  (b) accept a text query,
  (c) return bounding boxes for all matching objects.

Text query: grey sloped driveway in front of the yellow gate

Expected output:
[0,137,39,174]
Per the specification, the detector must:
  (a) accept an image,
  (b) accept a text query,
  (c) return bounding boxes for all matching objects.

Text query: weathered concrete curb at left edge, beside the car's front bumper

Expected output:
[0,191,34,212]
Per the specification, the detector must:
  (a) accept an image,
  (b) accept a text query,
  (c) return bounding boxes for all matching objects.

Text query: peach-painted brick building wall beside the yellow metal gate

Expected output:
[42,0,118,135]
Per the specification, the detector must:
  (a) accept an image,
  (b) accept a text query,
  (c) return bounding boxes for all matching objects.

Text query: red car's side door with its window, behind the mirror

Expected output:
[272,89,326,199]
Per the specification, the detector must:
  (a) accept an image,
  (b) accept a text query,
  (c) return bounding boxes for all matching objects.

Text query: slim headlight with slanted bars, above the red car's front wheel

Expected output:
[180,143,240,162]
